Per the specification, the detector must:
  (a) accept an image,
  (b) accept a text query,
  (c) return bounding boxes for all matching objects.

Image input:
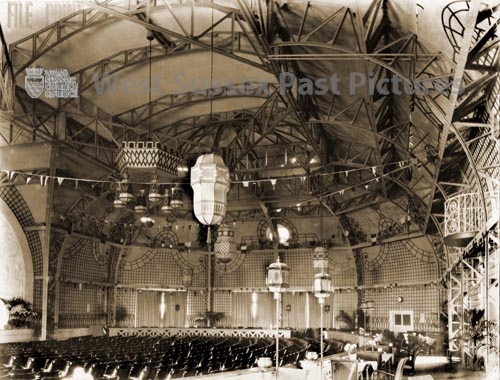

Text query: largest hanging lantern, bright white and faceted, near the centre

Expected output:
[191,153,229,225]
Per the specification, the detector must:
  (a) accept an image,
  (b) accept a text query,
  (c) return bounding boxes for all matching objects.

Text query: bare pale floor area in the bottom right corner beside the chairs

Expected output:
[408,356,486,380]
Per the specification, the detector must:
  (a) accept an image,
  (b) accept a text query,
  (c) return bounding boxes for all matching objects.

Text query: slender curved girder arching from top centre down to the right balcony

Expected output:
[270,42,488,216]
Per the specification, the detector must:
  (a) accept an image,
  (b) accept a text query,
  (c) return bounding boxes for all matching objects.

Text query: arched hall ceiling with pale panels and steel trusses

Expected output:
[0,0,499,240]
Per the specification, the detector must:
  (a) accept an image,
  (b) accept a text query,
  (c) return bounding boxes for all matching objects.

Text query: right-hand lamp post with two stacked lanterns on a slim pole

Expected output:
[313,247,332,376]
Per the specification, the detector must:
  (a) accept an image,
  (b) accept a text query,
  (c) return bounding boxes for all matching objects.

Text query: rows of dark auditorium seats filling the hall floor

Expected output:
[0,336,329,380]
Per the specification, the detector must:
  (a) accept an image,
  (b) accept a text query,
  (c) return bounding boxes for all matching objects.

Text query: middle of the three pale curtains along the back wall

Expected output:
[231,292,276,329]
